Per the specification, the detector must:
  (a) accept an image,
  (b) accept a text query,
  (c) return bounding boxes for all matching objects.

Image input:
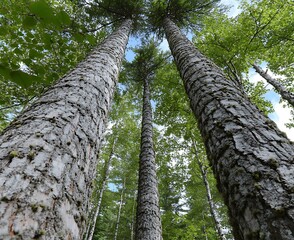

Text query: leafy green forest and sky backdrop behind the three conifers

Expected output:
[0,0,294,239]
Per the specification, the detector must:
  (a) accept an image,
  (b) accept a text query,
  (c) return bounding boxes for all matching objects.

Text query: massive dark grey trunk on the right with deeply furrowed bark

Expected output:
[164,18,294,240]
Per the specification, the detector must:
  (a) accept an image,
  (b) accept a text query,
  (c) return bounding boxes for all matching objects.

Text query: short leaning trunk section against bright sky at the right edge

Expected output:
[252,63,294,107]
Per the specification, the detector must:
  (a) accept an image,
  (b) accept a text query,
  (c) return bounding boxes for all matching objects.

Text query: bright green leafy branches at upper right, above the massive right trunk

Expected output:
[194,0,294,113]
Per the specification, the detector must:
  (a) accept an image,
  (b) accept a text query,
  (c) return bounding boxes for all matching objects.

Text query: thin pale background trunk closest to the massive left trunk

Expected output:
[86,138,116,240]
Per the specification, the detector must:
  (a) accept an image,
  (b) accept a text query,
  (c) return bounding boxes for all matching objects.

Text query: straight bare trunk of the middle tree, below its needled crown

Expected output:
[136,79,162,240]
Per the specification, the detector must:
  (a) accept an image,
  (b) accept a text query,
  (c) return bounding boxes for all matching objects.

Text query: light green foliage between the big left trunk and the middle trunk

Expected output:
[92,89,140,239]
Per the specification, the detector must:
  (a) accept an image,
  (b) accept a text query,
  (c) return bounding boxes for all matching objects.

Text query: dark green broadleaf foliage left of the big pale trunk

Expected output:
[0,0,104,126]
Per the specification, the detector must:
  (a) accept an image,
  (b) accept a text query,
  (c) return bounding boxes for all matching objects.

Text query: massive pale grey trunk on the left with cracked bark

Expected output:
[0,20,131,239]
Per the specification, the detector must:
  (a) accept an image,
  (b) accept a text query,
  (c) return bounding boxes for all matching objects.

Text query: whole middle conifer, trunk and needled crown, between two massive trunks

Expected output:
[127,42,163,240]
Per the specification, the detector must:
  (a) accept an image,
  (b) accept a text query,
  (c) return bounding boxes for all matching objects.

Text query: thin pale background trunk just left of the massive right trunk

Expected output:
[192,139,225,240]
